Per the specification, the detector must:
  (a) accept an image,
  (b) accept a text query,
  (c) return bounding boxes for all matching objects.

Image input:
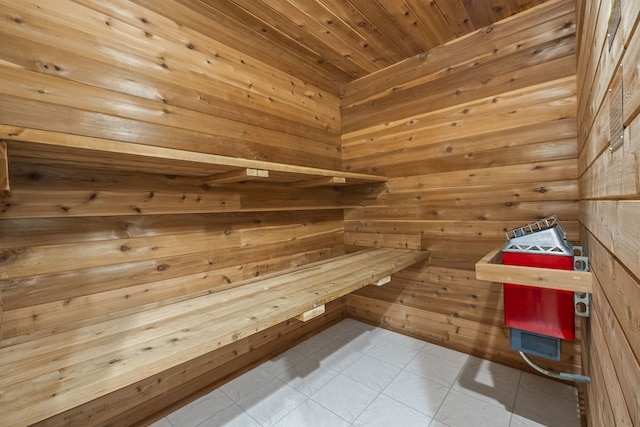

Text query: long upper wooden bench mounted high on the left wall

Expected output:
[0,125,387,188]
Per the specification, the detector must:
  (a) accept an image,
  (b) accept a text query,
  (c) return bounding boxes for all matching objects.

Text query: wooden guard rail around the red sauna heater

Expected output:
[476,248,593,294]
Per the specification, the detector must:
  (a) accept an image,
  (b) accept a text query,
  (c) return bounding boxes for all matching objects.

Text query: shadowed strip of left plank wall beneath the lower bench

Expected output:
[35,298,345,427]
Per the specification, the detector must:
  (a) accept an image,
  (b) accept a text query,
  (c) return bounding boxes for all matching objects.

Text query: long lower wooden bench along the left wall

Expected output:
[0,248,429,426]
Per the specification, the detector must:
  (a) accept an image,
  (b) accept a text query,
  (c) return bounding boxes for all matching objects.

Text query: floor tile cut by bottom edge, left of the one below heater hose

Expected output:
[435,390,511,427]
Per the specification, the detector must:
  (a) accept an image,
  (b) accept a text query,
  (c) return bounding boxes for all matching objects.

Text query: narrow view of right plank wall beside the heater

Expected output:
[577,0,640,426]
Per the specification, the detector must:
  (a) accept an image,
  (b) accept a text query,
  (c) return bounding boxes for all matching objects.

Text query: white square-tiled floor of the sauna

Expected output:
[154,319,580,427]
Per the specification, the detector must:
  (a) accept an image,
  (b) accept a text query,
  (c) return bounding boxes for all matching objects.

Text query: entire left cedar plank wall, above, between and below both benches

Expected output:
[0,0,345,425]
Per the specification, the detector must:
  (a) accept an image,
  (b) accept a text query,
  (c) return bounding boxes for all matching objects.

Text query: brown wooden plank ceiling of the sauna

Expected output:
[138,0,547,93]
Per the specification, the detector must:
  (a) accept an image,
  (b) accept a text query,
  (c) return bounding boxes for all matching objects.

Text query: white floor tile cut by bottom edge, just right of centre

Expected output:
[353,394,431,427]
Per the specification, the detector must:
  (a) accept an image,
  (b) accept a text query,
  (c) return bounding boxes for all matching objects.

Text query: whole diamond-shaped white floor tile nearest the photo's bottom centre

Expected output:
[311,375,378,422]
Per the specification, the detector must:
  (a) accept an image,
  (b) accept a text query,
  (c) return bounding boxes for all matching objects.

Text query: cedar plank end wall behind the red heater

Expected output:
[342,0,580,372]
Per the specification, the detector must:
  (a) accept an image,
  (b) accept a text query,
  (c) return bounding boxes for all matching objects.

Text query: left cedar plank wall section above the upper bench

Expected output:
[0,0,340,169]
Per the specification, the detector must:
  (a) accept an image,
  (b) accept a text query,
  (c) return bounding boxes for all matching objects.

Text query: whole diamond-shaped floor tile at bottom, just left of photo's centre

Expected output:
[238,378,306,426]
